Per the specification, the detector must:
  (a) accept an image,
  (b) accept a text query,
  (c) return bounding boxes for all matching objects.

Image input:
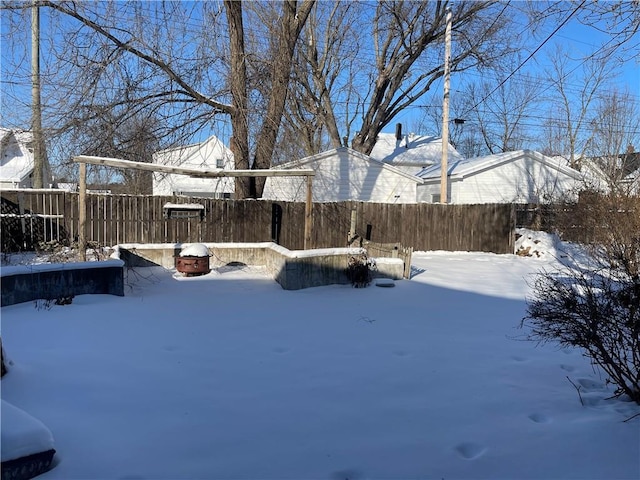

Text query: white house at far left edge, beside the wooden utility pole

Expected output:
[0,128,34,188]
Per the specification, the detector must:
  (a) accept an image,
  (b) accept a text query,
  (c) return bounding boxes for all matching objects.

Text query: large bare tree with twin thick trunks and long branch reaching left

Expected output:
[2,0,314,198]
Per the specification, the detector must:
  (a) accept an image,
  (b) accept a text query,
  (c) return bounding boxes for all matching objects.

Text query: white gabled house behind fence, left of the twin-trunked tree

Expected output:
[153,136,235,198]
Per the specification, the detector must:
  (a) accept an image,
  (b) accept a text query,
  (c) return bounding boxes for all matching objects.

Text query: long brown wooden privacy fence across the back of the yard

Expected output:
[1,190,515,253]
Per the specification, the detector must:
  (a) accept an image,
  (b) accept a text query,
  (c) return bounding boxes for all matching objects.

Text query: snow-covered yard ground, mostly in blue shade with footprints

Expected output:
[2,232,640,480]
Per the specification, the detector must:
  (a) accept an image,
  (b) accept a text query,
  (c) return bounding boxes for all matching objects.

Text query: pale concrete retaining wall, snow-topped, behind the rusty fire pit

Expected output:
[118,242,404,290]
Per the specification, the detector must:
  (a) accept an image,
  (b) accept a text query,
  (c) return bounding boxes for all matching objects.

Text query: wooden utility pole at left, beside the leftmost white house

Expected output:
[31,0,47,188]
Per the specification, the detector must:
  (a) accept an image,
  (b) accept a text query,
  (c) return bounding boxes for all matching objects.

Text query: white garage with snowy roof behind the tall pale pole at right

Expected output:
[417,150,583,204]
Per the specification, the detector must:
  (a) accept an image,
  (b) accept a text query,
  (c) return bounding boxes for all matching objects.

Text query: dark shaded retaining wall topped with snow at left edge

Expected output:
[0,260,124,307]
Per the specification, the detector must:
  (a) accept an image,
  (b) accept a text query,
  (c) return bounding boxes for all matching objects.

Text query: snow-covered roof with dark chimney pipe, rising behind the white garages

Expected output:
[369,133,463,166]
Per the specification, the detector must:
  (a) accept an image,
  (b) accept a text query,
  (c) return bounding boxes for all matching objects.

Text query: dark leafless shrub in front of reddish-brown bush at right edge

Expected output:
[521,269,640,404]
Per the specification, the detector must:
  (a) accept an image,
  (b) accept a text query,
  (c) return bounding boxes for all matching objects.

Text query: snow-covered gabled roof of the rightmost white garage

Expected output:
[417,150,582,181]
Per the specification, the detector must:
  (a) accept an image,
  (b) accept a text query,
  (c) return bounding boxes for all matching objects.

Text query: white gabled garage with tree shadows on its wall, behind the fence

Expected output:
[262,147,422,203]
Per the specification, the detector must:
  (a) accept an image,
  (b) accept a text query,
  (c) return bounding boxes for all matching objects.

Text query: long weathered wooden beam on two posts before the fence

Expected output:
[73,155,315,258]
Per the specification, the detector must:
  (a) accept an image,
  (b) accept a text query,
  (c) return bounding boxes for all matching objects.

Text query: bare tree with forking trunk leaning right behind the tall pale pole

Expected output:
[352,1,511,154]
